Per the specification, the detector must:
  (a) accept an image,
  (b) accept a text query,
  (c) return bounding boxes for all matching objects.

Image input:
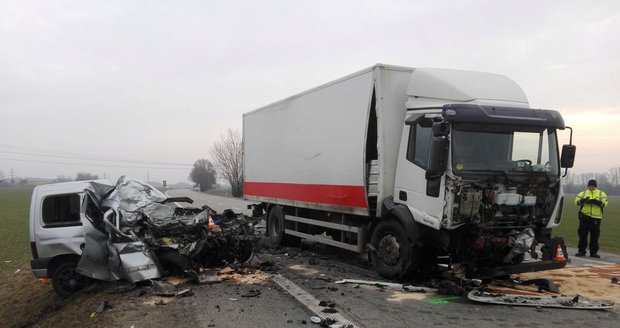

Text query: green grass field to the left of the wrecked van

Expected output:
[0,187,32,276]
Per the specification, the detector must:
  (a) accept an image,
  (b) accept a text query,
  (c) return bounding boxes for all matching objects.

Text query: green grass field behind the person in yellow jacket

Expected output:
[553,194,620,255]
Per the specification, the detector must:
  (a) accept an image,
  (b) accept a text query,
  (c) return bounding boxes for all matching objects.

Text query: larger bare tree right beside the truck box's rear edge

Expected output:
[210,128,243,197]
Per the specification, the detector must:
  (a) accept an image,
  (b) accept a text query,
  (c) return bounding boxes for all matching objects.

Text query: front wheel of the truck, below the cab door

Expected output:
[370,219,413,279]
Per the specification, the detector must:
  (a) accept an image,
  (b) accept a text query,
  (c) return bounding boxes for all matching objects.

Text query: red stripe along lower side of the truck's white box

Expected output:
[243,182,368,208]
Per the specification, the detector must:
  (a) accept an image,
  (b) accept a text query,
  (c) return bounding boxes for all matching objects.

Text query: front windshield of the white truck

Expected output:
[452,127,559,175]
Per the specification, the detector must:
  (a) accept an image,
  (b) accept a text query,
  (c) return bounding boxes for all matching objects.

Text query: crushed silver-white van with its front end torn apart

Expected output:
[30,177,255,297]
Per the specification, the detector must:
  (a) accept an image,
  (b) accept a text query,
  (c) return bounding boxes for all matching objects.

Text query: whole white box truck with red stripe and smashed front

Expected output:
[243,64,575,279]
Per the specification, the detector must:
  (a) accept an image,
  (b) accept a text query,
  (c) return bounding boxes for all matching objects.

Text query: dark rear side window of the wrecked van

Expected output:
[43,194,82,227]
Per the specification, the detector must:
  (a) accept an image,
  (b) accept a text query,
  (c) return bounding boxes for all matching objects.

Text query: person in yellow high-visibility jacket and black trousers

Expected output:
[575,180,607,258]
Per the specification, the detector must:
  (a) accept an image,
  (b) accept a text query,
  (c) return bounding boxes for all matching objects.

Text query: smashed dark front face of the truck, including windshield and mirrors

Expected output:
[427,105,574,278]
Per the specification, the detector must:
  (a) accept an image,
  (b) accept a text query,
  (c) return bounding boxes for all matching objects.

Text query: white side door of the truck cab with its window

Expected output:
[394,119,445,229]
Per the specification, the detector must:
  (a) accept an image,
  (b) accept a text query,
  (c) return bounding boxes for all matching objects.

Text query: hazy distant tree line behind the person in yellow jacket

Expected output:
[564,166,620,195]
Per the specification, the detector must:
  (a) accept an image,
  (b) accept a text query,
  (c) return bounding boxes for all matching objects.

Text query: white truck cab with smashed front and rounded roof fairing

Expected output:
[388,69,575,276]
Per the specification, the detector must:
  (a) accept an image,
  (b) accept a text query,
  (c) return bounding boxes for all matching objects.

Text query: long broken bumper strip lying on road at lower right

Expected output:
[467,289,614,310]
